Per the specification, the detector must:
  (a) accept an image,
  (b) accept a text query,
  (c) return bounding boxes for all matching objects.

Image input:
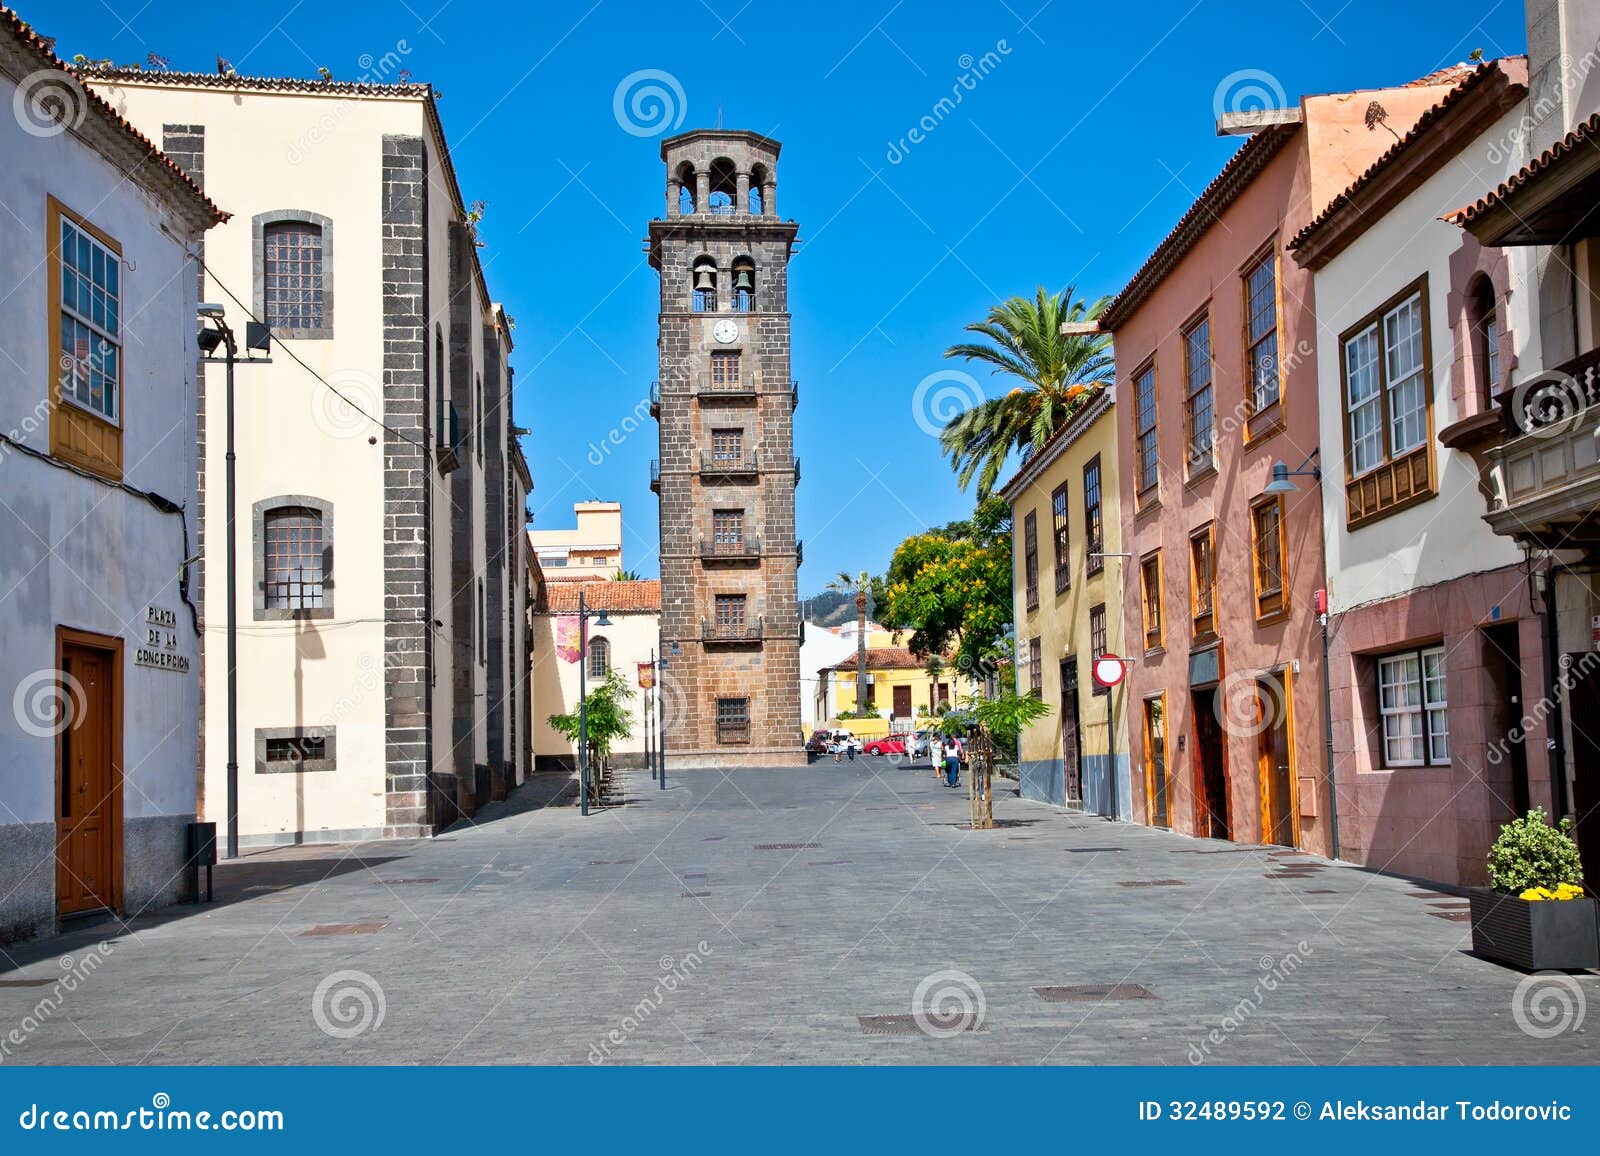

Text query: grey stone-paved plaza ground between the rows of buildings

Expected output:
[0,759,1600,1065]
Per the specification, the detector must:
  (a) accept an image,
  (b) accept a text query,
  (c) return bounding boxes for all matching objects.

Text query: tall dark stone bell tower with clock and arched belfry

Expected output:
[650,128,805,767]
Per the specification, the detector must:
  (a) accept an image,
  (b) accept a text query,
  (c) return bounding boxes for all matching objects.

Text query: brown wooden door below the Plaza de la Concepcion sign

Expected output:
[56,639,122,916]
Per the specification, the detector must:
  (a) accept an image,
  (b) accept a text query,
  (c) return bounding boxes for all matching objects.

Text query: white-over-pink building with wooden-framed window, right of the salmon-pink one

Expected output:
[1290,56,1552,884]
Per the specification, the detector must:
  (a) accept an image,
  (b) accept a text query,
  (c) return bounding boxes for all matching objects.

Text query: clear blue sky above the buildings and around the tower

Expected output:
[46,0,1525,594]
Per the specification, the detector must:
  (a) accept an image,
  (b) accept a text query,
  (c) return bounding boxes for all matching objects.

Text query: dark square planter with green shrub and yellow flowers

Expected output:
[1472,807,1600,972]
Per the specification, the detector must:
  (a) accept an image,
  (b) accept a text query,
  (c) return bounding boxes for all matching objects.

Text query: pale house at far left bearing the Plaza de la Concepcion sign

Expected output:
[0,8,226,943]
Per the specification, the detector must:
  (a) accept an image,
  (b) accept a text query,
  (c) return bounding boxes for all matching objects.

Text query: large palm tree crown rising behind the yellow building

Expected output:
[939,285,1114,500]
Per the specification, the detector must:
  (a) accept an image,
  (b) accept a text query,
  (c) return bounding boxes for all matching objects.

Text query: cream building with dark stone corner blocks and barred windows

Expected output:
[91,58,530,847]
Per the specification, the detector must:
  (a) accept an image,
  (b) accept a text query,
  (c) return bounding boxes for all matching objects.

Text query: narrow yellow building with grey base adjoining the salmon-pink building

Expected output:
[1000,389,1133,818]
